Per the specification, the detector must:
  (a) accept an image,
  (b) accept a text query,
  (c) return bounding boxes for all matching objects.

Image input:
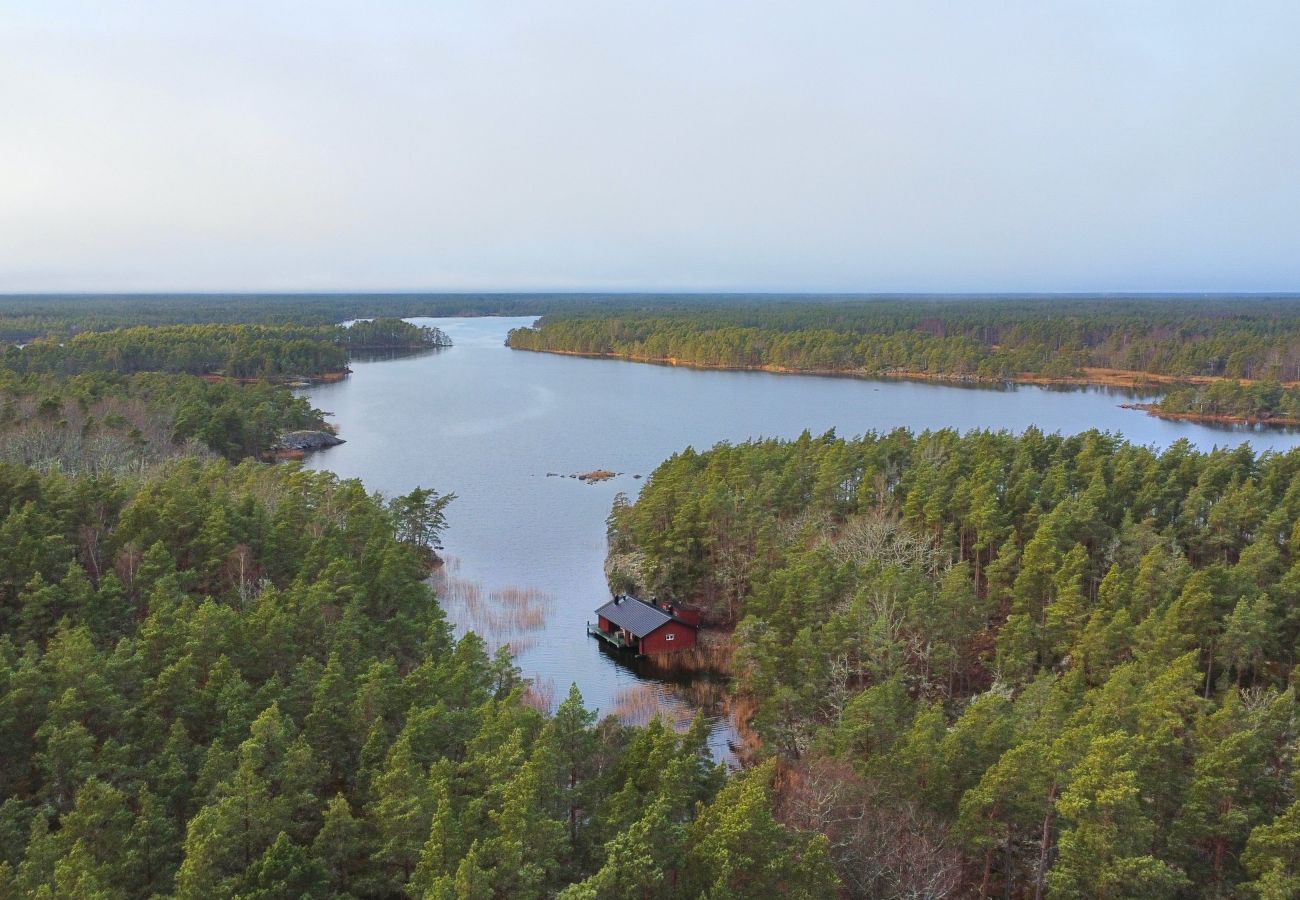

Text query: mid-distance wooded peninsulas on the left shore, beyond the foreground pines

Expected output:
[0,319,450,473]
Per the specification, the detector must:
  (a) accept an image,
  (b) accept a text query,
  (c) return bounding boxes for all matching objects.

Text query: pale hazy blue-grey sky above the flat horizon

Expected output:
[0,0,1300,291]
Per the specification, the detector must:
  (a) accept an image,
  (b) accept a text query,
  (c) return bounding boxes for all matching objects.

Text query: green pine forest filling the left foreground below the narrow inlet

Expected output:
[0,458,835,899]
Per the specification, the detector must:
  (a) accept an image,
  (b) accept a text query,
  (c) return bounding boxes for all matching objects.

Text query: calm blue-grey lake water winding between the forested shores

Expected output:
[306,317,1300,756]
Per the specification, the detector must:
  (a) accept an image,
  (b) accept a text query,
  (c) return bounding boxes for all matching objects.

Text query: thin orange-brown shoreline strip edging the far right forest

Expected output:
[506,343,1300,392]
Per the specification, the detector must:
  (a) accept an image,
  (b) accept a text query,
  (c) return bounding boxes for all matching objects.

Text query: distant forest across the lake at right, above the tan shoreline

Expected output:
[510,298,1300,381]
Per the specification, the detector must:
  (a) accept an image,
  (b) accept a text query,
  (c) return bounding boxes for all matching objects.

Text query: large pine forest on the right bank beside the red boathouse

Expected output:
[610,429,1300,899]
